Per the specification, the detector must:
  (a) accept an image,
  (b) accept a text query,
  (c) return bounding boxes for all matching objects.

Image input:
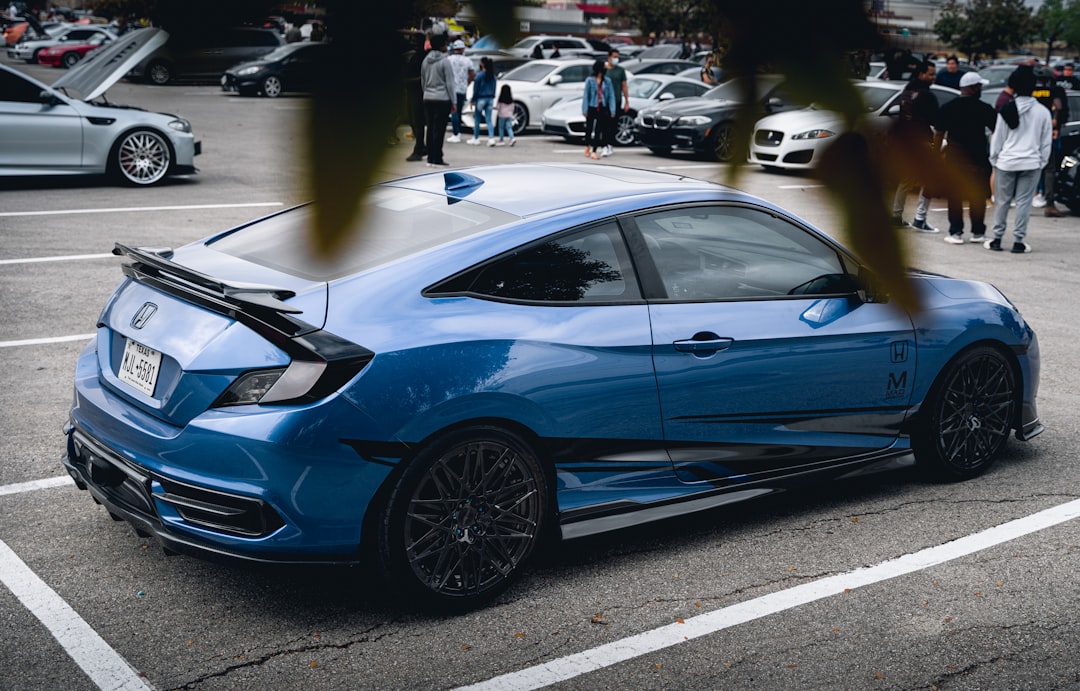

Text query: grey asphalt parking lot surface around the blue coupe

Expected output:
[0,58,1080,689]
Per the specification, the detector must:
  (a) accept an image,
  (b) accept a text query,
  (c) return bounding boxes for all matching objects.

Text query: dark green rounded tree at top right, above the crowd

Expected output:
[933,0,1037,60]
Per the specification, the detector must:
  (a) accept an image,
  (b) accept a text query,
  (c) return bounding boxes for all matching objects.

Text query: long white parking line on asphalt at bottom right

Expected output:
[461,500,1080,691]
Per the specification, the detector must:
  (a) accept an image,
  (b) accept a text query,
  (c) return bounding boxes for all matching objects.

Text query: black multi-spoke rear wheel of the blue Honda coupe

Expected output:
[378,426,548,610]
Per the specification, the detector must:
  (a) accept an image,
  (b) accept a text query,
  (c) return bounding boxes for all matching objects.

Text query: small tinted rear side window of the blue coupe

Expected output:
[427,222,640,302]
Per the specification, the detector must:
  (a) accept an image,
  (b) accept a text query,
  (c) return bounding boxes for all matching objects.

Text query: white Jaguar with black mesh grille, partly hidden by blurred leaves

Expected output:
[750,81,960,171]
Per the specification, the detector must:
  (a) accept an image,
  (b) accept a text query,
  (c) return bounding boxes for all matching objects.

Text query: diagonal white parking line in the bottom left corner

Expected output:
[0,541,150,691]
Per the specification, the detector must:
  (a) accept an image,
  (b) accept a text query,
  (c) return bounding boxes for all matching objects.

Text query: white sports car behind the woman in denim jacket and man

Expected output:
[540,74,711,147]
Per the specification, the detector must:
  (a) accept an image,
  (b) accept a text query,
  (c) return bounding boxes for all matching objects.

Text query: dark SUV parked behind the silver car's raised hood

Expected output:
[129,27,284,84]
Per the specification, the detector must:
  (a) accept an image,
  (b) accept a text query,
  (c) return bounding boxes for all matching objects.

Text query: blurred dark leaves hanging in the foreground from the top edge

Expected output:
[295,0,980,308]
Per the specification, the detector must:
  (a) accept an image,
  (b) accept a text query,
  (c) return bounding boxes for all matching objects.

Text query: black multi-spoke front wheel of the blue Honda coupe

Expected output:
[912,346,1017,480]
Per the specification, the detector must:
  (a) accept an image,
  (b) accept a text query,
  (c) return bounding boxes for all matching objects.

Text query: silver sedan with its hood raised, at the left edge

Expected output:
[0,28,202,186]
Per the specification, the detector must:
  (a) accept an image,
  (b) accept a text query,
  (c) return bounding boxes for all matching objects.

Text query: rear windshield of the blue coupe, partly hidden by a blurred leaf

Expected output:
[208,188,517,281]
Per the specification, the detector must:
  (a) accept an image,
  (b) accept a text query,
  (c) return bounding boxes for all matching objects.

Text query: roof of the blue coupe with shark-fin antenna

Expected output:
[387,163,735,217]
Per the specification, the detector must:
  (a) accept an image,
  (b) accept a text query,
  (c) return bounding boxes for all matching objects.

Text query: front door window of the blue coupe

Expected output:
[637,206,854,300]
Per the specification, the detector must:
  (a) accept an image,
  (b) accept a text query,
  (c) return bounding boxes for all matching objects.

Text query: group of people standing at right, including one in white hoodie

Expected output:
[891,56,1080,254]
